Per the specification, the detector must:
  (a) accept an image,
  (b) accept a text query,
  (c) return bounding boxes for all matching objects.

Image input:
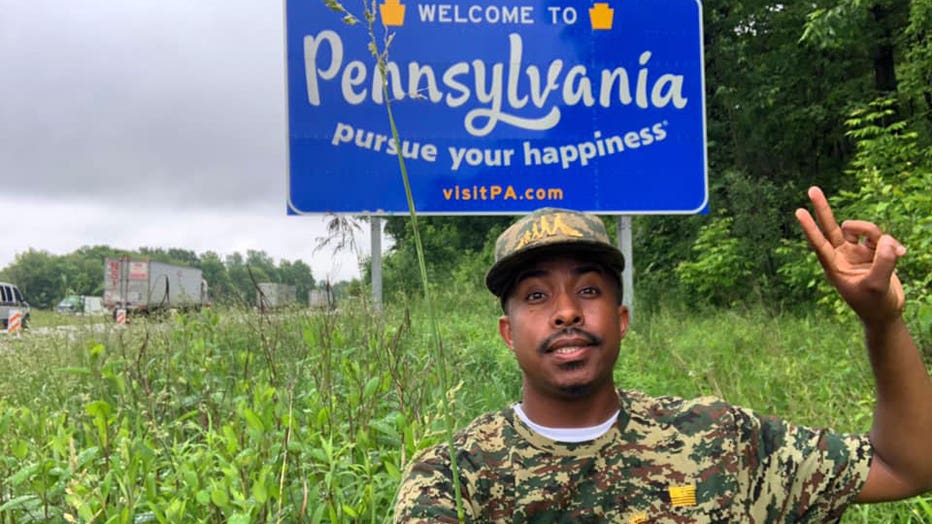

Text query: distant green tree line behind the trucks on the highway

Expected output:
[0,246,347,309]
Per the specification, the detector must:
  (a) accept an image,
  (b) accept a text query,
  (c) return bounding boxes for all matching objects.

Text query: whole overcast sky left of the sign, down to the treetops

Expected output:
[0,0,378,281]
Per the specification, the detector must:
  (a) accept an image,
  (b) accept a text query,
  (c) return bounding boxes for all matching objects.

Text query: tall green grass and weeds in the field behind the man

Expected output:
[0,294,932,523]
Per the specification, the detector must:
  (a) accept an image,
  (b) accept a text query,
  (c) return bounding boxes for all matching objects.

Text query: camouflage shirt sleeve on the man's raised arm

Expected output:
[734,408,873,522]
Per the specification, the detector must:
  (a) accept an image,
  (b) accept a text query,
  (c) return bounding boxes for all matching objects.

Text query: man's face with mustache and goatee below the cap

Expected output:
[499,257,628,399]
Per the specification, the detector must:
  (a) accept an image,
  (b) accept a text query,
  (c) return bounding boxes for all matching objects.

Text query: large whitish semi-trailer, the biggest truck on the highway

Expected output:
[104,257,210,313]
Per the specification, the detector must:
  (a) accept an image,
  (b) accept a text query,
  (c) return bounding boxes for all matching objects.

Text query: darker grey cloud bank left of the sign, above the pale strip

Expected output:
[0,0,286,209]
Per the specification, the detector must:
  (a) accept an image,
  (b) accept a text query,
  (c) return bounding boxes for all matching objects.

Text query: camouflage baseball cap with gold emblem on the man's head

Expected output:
[485,207,625,300]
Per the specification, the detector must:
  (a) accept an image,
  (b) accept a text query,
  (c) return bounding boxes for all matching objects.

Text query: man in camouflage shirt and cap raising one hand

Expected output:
[395,188,932,523]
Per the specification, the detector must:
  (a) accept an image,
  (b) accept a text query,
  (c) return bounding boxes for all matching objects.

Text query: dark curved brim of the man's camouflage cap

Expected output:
[485,241,625,297]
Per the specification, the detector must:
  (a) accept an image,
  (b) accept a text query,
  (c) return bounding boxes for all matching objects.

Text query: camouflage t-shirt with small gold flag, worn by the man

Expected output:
[395,391,873,523]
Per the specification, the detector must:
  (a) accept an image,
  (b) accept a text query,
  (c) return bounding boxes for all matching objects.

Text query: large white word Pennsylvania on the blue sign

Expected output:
[304,30,687,137]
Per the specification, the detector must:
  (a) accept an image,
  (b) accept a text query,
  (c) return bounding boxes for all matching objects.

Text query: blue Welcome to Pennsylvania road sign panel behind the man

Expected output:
[285,0,708,214]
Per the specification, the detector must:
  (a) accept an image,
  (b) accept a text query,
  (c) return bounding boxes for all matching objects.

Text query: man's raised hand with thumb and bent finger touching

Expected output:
[796,187,906,323]
